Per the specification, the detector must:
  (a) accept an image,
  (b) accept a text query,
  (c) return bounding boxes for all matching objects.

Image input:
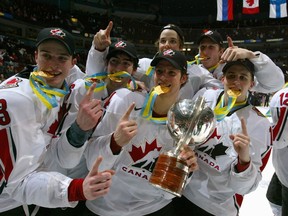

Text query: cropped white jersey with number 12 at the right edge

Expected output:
[269,87,288,187]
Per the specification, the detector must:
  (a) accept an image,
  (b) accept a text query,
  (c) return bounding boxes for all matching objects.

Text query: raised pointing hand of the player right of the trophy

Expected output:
[230,118,251,164]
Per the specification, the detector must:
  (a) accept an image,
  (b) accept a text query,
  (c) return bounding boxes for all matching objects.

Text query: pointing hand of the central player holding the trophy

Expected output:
[114,103,138,147]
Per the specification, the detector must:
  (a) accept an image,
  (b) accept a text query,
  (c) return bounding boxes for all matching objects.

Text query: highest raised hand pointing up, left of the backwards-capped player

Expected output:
[93,21,113,51]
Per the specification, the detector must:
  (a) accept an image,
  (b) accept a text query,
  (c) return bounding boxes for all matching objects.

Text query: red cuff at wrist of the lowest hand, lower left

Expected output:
[68,179,86,202]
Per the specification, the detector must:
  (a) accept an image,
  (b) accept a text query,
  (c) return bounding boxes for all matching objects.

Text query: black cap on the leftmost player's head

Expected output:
[36,27,75,55]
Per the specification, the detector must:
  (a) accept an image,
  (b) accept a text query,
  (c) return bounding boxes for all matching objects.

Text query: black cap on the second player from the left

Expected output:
[106,40,138,63]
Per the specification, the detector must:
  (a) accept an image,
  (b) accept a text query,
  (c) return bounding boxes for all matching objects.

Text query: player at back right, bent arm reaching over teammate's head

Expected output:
[197,30,284,93]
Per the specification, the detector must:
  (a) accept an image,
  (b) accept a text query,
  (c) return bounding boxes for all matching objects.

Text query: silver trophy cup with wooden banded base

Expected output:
[149,97,216,197]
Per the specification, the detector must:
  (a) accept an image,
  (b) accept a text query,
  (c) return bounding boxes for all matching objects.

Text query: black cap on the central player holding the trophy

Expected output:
[151,49,187,73]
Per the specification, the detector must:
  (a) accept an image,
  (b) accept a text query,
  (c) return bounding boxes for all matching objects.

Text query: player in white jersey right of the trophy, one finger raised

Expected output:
[174,59,271,216]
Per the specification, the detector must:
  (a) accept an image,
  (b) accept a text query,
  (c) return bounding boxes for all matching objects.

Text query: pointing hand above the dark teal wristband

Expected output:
[76,83,103,131]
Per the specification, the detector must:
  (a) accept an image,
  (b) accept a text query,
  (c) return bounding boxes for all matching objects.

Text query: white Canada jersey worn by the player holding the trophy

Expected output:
[85,89,179,216]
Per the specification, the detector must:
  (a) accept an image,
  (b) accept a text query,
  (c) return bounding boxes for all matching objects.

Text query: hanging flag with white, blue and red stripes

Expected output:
[217,0,233,21]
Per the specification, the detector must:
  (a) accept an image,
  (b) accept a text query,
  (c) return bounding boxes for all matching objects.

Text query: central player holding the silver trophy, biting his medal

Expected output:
[85,50,197,216]
